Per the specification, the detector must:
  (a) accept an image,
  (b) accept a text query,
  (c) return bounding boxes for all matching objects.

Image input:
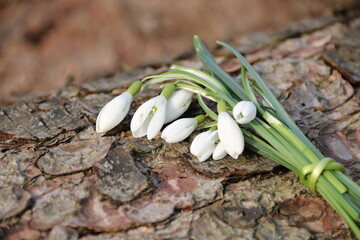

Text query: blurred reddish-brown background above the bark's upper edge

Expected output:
[0,0,356,102]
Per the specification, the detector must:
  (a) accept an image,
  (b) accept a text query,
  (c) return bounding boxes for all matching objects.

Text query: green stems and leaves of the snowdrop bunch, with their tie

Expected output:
[142,36,360,239]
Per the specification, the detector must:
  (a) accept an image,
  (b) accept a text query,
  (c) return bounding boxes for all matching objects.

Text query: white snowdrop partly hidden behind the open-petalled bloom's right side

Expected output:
[165,89,194,123]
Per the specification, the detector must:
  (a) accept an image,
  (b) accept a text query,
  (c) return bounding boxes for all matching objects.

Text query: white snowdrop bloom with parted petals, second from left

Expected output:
[130,95,167,140]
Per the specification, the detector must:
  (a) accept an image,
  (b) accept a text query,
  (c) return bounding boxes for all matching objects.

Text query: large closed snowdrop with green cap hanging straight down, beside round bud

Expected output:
[218,101,244,159]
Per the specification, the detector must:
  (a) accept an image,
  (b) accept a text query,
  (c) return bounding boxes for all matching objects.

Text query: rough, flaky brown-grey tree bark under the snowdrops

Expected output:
[0,9,360,240]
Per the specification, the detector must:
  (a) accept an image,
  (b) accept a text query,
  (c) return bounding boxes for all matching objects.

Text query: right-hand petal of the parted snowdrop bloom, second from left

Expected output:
[147,95,167,140]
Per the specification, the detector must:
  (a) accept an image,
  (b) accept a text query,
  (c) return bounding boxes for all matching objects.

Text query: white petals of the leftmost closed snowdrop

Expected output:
[96,92,132,132]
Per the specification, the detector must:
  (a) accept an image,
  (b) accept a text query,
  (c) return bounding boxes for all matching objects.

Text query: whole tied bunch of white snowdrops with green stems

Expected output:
[96,36,360,238]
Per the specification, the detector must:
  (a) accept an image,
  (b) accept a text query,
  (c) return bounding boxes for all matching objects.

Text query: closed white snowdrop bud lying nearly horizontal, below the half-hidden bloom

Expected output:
[161,118,198,143]
